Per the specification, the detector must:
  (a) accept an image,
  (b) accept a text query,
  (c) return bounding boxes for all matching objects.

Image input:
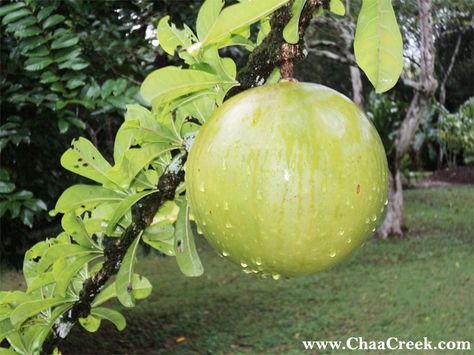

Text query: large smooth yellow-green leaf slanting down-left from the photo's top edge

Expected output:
[203,0,288,45]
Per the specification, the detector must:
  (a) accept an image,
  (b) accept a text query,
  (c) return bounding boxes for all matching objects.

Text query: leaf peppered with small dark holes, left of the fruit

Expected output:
[61,137,115,184]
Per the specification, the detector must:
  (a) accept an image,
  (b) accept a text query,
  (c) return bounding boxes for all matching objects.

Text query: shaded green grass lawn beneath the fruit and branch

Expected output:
[1,187,474,354]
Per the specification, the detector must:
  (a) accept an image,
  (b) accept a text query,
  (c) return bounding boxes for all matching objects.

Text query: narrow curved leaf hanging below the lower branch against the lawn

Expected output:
[115,235,141,307]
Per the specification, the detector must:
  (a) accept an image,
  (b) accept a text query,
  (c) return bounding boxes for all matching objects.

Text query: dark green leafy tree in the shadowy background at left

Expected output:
[0,0,199,266]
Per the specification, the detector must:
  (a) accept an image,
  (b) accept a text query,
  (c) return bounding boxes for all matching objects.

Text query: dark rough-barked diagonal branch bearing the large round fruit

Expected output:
[42,0,322,354]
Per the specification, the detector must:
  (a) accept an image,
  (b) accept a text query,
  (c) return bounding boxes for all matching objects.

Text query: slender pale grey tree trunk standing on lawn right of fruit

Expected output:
[377,0,438,239]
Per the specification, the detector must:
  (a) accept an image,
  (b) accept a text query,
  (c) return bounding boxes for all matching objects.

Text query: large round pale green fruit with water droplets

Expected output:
[186,82,388,278]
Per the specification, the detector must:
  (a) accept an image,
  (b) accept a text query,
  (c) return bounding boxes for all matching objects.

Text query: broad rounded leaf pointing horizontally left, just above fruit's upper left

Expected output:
[140,66,236,105]
